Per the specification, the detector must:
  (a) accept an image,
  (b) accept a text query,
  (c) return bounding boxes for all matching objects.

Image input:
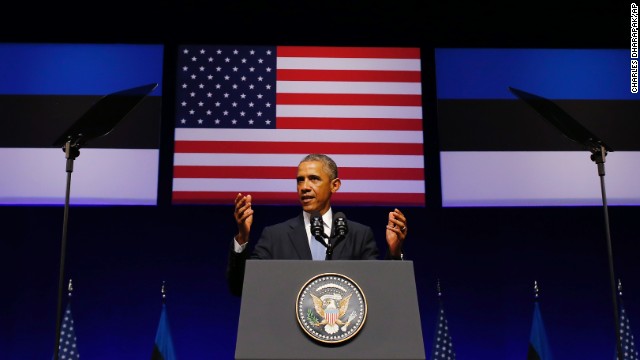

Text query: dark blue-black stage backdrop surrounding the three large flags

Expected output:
[0,1,640,360]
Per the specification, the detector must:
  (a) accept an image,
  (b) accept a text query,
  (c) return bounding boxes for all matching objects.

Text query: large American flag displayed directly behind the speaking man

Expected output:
[173,45,425,206]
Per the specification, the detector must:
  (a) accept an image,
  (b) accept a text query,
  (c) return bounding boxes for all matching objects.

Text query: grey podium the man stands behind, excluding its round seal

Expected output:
[235,260,425,360]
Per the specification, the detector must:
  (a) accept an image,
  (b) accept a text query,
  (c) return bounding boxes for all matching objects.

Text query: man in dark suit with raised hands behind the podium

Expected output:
[227,154,407,295]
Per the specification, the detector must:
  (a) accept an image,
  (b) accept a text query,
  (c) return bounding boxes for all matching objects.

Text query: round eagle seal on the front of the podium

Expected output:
[296,273,367,344]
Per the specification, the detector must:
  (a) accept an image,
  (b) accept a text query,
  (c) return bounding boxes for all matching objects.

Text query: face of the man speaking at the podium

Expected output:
[296,161,340,215]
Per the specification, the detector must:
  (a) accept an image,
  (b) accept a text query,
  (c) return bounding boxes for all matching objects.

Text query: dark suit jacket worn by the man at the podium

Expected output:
[227,214,379,295]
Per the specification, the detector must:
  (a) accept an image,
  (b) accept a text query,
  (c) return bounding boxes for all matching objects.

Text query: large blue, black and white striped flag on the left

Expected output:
[0,43,163,205]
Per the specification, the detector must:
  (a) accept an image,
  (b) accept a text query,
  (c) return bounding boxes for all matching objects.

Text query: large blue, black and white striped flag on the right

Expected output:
[435,49,640,207]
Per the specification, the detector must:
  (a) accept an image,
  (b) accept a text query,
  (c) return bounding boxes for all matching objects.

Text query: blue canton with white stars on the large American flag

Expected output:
[176,45,276,129]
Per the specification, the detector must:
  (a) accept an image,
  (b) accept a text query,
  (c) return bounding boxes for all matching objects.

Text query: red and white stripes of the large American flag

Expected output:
[173,47,425,206]
